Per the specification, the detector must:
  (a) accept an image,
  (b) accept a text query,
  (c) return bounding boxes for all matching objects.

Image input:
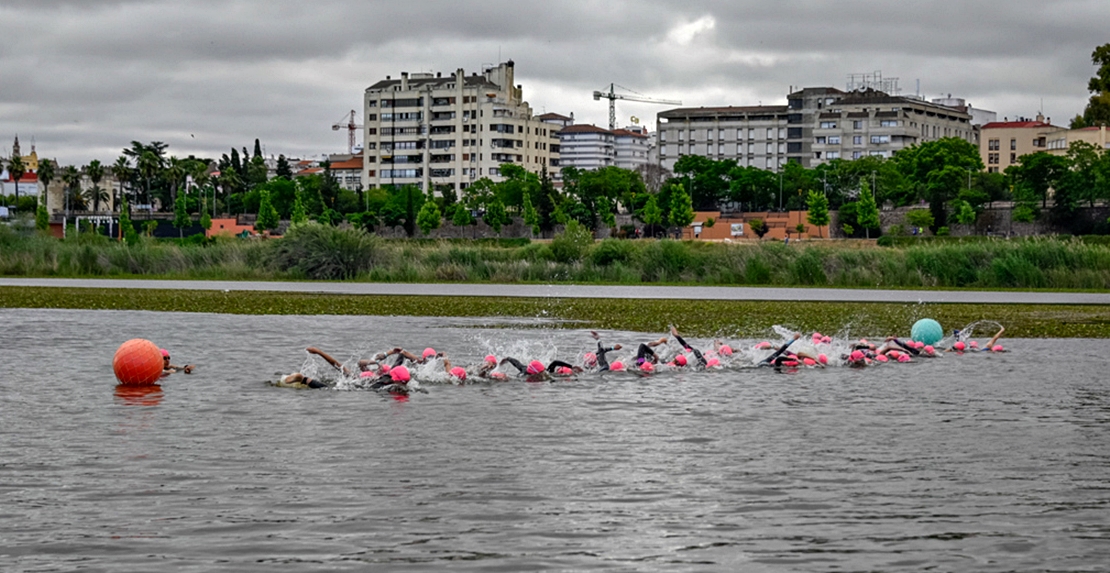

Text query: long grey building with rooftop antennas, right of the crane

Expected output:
[658,83,976,170]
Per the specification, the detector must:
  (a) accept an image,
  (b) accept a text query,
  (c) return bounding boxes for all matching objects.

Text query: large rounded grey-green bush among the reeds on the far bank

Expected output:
[271,223,381,280]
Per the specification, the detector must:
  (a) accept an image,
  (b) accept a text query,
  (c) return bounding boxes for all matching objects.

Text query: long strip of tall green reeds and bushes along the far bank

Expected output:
[0,221,1110,290]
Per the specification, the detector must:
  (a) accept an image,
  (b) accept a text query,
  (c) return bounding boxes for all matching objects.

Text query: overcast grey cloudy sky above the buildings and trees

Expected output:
[0,0,1110,165]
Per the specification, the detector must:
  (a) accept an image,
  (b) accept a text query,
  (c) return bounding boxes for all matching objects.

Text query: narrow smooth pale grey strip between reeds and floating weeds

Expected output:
[0,278,1110,304]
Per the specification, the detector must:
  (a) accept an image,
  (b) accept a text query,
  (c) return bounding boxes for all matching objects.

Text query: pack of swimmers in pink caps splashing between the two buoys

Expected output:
[275,326,1006,392]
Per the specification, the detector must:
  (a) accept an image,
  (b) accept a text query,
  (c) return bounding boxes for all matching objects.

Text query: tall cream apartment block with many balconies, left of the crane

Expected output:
[362,61,558,193]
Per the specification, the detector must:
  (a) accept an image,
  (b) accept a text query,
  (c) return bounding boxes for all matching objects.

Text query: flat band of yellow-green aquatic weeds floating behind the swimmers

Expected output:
[0,287,1110,338]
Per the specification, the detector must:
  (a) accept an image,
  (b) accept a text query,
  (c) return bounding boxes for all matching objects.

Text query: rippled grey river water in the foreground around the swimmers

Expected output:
[0,310,1110,572]
